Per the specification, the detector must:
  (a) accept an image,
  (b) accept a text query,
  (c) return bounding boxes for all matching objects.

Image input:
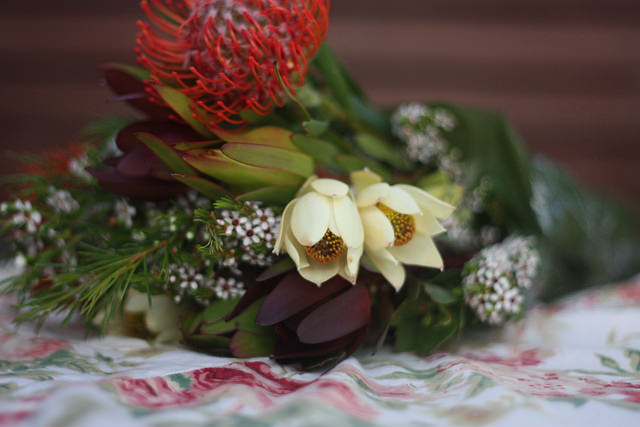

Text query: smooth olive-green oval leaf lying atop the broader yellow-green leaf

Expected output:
[221,143,315,178]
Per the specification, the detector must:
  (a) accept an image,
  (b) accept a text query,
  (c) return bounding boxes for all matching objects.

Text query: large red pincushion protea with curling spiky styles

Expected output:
[136,0,329,129]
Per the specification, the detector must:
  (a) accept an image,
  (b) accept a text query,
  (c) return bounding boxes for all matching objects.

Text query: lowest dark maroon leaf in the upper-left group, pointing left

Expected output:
[87,167,188,200]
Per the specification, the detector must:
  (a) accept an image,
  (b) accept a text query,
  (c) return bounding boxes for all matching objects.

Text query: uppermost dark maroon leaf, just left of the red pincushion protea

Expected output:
[102,64,172,119]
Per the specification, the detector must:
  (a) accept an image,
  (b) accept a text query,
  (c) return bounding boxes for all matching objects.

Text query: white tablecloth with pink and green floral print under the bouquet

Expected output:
[0,268,640,426]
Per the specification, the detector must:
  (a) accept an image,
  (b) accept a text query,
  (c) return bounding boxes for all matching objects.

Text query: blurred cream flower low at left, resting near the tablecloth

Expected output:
[93,290,180,344]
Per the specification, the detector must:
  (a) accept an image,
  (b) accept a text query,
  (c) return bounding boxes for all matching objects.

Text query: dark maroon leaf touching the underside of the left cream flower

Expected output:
[256,272,351,326]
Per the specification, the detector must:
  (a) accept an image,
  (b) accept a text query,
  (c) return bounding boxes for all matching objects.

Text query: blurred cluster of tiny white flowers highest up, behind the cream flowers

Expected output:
[391,103,462,180]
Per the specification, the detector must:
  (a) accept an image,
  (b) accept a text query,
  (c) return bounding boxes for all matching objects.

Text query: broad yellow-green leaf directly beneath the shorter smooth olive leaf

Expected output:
[184,150,304,193]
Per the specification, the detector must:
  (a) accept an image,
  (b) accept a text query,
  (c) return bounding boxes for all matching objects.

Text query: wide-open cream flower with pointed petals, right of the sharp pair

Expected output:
[351,170,455,289]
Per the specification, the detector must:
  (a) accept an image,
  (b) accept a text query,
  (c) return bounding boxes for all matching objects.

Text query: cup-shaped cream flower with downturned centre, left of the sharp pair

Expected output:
[274,176,364,286]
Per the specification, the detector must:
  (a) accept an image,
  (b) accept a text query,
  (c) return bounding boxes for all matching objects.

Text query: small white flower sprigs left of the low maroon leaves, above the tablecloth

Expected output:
[167,262,245,305]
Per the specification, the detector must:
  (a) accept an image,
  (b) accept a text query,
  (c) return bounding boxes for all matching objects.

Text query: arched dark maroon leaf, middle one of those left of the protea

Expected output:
[116,120,202,152]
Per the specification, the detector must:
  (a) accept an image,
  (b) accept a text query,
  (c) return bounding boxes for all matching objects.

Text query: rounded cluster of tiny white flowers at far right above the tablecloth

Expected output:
[463,237,540,325]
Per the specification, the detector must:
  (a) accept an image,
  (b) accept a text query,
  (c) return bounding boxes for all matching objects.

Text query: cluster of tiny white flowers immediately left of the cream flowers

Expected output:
[217,202,280,267]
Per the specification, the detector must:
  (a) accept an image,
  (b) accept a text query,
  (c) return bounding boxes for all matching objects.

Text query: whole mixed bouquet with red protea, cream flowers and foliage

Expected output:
[0,0,640,368]
